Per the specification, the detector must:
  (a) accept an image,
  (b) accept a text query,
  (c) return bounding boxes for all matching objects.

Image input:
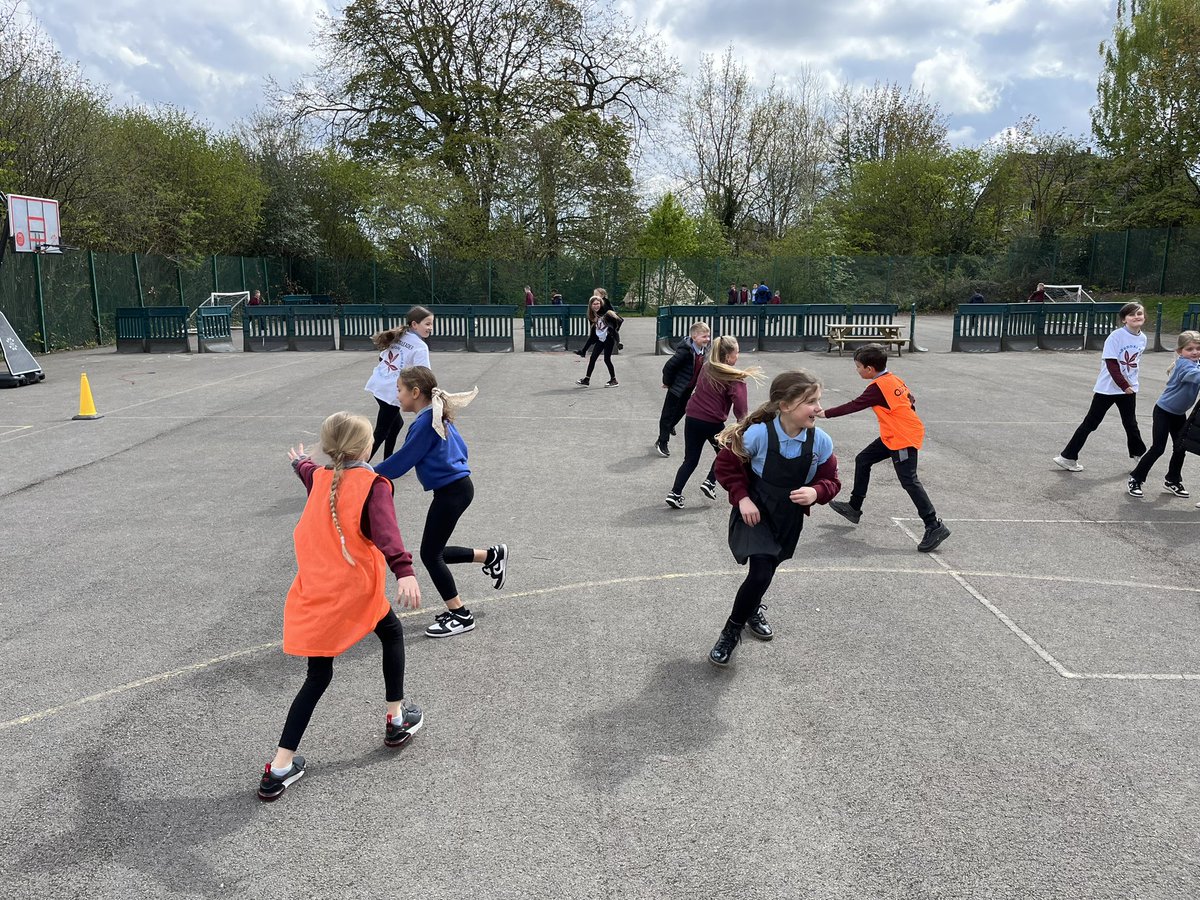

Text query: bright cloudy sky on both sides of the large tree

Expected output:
[26,0,1116,144]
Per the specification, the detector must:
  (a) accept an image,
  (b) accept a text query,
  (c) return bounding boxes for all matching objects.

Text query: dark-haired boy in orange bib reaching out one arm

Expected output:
[821,343,950,553]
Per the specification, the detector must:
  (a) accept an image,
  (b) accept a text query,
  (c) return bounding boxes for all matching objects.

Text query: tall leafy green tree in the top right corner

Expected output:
[1092,0,1200,226]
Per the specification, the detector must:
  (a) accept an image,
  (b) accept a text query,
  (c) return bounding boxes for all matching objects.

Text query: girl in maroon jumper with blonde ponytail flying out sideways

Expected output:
[666,335,762,509]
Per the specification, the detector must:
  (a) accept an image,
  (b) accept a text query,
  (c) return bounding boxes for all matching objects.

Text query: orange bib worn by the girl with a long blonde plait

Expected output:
[283,468,391,656]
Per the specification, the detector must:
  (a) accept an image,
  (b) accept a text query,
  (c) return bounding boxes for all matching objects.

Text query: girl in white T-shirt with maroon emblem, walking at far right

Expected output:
[1054,302,1146,472]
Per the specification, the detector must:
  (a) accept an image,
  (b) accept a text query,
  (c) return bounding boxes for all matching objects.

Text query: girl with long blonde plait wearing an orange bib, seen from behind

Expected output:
[258,413,425,800]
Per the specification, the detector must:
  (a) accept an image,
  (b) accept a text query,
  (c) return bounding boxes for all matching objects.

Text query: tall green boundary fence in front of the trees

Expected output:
[0,228,1200,350]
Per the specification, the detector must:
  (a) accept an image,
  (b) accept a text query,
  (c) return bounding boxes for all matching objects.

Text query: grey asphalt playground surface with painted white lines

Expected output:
[0,318,1200,900]
